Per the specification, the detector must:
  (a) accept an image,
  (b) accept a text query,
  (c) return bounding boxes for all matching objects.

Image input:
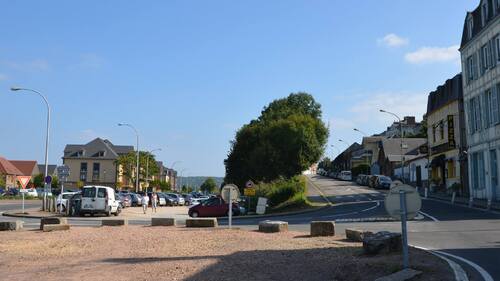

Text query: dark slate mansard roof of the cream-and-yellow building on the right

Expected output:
[427,73,464,114]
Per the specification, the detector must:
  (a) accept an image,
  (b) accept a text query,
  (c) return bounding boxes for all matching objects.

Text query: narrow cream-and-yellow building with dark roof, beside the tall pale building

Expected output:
[426,74,469,195]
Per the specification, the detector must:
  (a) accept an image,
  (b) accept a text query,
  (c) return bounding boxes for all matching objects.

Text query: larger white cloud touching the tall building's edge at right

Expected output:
[405,45,460,64]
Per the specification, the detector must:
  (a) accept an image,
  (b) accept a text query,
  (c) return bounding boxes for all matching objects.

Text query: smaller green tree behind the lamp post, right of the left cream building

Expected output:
[117,151,160,187]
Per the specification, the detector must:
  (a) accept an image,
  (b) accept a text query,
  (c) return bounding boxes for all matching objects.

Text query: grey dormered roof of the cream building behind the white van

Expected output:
[63,138,134,159]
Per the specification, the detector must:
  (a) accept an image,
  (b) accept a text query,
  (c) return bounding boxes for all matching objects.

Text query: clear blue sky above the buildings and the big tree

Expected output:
[0,0,479,176]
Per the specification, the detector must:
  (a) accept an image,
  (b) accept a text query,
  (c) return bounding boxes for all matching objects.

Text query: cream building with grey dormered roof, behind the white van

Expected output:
[62,138,134,187]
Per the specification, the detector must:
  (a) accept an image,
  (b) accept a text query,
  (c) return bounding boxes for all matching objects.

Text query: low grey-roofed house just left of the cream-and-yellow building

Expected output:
[378,138,427,177]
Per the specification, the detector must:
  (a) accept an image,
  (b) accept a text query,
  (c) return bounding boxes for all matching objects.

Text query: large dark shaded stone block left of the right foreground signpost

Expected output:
[363,231,402,255]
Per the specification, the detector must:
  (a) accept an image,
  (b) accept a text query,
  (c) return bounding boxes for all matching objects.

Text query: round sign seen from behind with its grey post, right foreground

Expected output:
[384,184,422,268]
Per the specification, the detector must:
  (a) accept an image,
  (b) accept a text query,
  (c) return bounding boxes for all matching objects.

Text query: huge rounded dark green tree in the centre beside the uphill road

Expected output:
[225,93,328,187]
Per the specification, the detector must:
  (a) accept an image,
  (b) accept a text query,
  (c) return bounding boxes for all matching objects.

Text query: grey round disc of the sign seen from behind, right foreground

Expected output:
[384,184,422,220]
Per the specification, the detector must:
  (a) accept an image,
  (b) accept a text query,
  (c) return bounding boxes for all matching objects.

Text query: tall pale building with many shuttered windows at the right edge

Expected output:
[460,0,500,202]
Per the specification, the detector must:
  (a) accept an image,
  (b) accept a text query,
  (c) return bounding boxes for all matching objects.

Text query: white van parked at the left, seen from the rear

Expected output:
[80,186,122,216]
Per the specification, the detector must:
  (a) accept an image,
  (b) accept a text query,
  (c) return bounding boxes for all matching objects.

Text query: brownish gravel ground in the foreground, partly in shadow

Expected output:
[0,226,453,281]
